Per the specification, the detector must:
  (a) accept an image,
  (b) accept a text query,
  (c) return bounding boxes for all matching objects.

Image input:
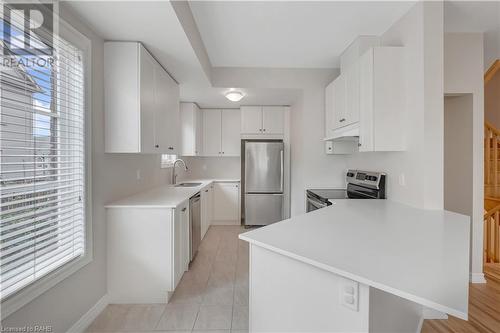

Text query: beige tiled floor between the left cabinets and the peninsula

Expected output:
[88,226,248,333]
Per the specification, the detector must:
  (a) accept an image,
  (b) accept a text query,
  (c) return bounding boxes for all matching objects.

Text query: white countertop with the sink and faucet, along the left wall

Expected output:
[104,179,240,208]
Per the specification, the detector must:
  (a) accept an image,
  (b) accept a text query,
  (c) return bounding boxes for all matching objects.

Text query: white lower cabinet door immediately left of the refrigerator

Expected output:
[213,183,240,221]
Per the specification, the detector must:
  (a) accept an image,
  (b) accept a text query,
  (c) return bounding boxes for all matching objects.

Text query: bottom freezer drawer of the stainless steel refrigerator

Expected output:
[245,194,284,225]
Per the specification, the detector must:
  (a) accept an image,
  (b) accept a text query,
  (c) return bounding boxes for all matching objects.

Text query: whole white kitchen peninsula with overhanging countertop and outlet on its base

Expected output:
[240,200,470,332]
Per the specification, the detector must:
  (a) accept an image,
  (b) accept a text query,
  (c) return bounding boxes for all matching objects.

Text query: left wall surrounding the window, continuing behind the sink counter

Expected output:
[2,5,169,332]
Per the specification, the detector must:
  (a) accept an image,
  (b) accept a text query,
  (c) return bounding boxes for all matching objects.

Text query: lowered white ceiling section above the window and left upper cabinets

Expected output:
[64,0,209,84]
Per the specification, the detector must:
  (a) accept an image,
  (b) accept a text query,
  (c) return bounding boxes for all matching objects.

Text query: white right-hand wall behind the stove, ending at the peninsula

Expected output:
[347,2,443,209]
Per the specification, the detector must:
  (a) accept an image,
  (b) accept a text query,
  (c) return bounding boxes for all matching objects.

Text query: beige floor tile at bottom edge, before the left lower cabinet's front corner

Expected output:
[156,303,199,331]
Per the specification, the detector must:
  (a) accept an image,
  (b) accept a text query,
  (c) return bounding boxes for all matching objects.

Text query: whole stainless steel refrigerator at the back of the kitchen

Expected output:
[242,140,284,225]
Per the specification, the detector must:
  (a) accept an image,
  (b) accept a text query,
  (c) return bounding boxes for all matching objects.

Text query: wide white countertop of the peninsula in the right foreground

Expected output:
[239,199,470,319]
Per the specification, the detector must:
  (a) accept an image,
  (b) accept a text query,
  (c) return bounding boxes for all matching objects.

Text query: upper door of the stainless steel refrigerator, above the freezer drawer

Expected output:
[245,142,283,193]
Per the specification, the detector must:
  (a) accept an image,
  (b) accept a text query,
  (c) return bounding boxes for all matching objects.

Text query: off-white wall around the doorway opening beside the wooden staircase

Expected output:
[444,33,484,282]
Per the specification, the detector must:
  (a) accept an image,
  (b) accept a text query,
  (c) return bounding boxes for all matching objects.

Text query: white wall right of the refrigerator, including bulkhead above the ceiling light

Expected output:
[212,67,346,216]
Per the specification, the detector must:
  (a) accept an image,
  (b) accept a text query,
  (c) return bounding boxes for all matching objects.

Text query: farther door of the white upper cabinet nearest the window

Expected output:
[155,64,180,154]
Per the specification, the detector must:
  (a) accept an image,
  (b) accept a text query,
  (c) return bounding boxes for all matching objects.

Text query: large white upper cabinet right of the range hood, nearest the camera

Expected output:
[359,47,406,152]
